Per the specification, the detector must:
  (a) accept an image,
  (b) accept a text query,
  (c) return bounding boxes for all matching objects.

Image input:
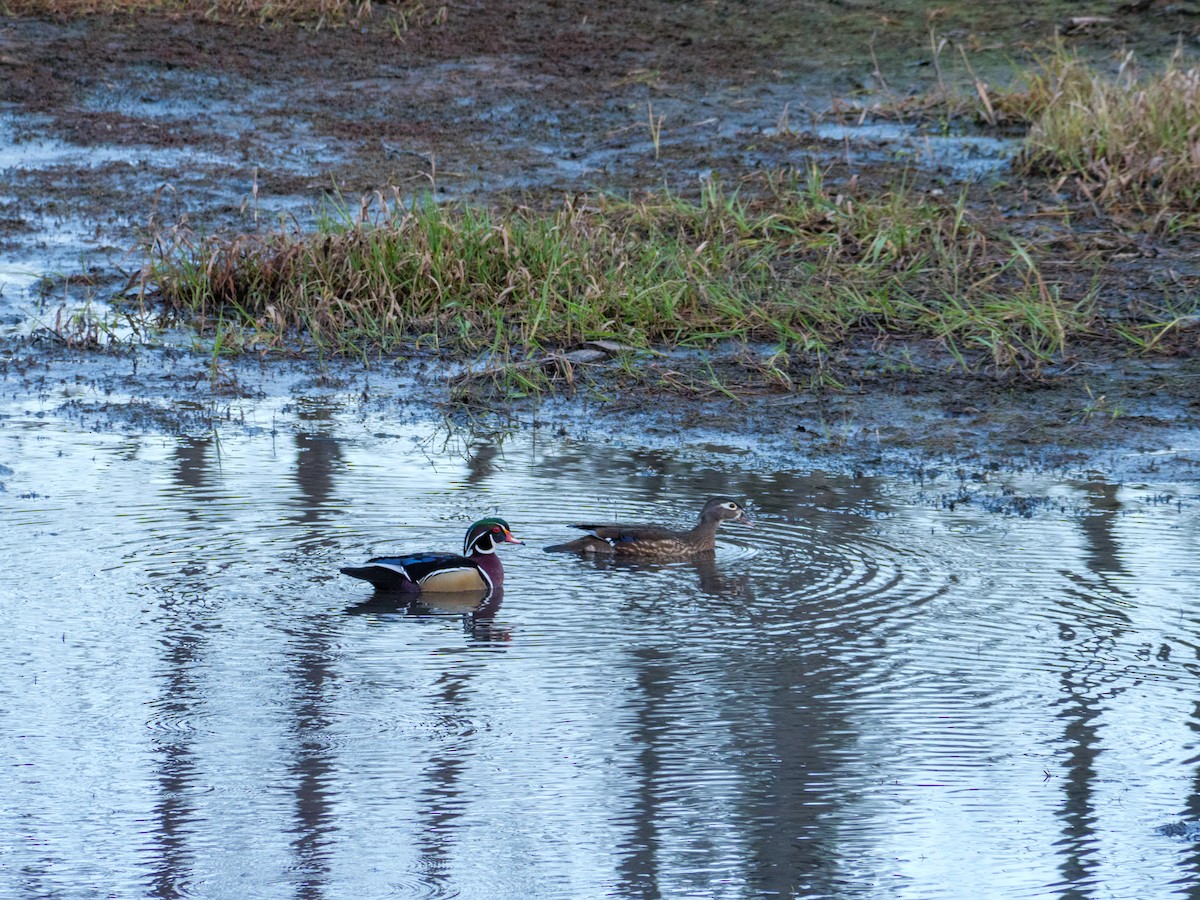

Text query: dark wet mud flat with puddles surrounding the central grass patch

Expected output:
[0,1,1200,479]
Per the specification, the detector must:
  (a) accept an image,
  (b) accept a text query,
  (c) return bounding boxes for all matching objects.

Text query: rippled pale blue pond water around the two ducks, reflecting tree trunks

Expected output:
[0,400,1200,899]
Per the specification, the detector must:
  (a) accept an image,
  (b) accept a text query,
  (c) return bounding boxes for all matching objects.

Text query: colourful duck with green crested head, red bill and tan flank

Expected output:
[342,518,524,593]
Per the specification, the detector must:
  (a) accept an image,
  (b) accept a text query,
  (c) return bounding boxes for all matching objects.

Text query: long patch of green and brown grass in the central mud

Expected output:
[144,170,1123,381]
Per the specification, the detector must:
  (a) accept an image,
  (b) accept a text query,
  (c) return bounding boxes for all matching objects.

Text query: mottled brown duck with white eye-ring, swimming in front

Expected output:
[546,497,754,559]
